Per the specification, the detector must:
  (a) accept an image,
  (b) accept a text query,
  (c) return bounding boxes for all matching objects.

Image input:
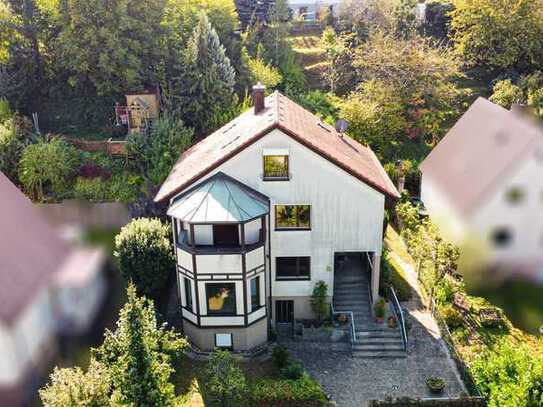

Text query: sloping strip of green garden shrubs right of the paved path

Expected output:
[396,202,543,407]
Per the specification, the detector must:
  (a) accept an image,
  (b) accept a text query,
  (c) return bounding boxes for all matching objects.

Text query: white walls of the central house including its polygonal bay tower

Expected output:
[170,129,385,346]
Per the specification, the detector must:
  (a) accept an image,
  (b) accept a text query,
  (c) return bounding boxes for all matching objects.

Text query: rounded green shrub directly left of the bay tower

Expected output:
[115,218,175,296]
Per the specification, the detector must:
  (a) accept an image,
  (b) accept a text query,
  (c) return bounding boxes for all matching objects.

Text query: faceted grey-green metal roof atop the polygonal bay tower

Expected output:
[168,172,268,223]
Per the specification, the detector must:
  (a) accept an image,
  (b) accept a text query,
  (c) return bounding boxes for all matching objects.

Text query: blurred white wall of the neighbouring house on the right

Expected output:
[421,142,543,280]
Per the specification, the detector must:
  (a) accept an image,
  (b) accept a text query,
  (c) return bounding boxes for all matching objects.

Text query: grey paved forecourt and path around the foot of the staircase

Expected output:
[286,253,466,407]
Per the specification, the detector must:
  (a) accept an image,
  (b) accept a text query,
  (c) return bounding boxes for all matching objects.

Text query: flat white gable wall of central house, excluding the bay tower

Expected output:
[181,129,385,296]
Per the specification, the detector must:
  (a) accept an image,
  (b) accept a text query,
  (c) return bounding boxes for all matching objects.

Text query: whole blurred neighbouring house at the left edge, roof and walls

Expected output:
[0,172,105,406]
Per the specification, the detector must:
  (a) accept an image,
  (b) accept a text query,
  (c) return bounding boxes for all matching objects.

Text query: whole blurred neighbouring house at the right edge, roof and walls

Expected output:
[420,98,543,281]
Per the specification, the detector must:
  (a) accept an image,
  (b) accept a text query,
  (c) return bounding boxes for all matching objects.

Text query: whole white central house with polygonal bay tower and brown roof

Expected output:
[155,85,398,351]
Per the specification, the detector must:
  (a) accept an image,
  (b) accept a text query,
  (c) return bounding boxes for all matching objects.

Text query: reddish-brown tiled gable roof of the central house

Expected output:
[155,92,399,202]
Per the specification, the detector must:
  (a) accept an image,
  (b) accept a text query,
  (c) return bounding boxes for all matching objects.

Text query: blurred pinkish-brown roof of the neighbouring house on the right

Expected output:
[420,97,543,213]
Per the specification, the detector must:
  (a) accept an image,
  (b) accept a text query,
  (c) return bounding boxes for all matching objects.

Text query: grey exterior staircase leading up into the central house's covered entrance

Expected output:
[333,257,407,358]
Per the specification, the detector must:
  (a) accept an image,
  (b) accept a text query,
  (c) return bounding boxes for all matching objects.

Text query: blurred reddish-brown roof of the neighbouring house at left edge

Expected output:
[0,172,70,323]
